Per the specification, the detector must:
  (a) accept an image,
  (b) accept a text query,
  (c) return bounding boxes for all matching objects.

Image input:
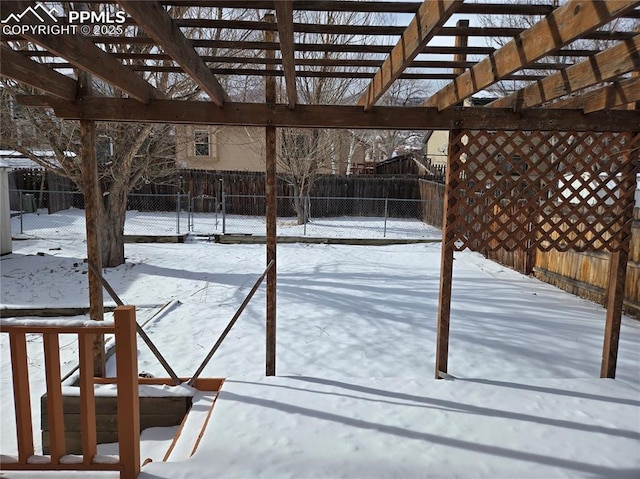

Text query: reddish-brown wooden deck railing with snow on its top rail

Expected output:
[0,306,140,479]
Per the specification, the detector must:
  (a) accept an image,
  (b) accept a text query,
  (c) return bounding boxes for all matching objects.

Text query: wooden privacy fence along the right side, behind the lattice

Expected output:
[420,133,640,317]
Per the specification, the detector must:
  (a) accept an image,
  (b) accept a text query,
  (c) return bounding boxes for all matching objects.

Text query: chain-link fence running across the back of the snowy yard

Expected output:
[10,190,441,239]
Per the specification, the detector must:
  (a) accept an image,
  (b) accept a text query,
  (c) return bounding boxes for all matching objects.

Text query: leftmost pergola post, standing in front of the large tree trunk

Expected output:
[78,72,105,377]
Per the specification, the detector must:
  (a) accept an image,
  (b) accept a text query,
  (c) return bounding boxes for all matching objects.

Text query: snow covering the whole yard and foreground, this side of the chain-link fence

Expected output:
[0,234,640,479]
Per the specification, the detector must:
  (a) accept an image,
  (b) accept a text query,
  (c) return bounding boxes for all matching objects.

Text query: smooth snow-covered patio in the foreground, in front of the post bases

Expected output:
[141,377,640,479]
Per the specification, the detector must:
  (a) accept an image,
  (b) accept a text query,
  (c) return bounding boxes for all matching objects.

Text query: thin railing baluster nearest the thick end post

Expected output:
[78,334,98,464]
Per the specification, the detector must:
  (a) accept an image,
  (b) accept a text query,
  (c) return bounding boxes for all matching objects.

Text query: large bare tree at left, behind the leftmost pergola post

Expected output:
[0,4,264,267]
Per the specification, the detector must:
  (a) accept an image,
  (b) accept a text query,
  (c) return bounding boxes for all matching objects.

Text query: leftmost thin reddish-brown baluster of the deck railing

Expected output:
[9,331,33,464]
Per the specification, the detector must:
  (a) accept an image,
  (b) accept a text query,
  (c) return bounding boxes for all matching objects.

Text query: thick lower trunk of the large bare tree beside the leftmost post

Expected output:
[101,191,127,268]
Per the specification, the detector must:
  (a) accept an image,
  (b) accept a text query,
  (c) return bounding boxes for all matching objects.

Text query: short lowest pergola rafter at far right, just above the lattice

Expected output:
[549,76,640,113]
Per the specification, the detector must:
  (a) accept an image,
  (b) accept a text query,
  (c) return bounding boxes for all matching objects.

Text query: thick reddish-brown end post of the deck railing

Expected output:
[114,306,140,479]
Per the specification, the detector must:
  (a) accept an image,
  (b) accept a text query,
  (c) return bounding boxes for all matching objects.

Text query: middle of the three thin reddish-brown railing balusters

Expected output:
[43,333,66,464]
